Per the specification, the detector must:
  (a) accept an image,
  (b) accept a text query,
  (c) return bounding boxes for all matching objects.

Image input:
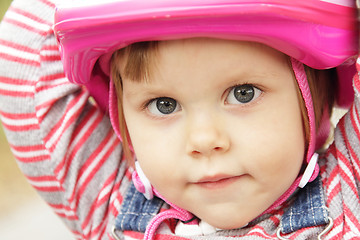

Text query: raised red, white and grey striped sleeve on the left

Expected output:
[0,0,130,239]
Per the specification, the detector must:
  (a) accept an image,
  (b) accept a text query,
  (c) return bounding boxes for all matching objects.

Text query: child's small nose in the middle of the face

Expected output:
[186,116,230,157]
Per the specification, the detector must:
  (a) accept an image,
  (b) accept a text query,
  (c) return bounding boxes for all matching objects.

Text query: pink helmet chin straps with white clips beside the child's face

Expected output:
[109,58,320,240]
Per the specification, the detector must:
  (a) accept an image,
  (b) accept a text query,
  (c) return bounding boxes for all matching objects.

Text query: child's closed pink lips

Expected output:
[194,175,243,189]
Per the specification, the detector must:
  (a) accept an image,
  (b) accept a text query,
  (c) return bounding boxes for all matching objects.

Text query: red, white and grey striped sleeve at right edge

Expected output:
[322,55,360,239]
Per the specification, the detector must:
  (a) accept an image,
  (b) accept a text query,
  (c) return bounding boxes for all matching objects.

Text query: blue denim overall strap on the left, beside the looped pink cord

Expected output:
[115,183,164,232]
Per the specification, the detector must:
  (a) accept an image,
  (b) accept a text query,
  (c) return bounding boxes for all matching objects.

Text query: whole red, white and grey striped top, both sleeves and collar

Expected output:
[0,0,360,239]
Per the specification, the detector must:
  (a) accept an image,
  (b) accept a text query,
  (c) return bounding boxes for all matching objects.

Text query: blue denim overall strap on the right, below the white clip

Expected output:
[281,177,329,234]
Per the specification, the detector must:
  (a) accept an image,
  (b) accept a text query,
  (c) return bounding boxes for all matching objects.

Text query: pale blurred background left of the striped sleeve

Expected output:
[0,0,73,240]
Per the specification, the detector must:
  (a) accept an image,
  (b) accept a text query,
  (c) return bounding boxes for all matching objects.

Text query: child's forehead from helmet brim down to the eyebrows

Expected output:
[123,38,294,101]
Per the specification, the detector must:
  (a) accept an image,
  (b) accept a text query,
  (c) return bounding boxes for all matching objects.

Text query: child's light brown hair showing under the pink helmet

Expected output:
[111,41,337,161]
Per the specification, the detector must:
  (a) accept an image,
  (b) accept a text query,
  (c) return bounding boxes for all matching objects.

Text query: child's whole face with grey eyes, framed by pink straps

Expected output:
[123,39,305,229]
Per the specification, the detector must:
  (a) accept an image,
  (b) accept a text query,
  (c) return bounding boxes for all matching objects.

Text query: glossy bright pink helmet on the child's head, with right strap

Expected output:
[54,0,358,218]
